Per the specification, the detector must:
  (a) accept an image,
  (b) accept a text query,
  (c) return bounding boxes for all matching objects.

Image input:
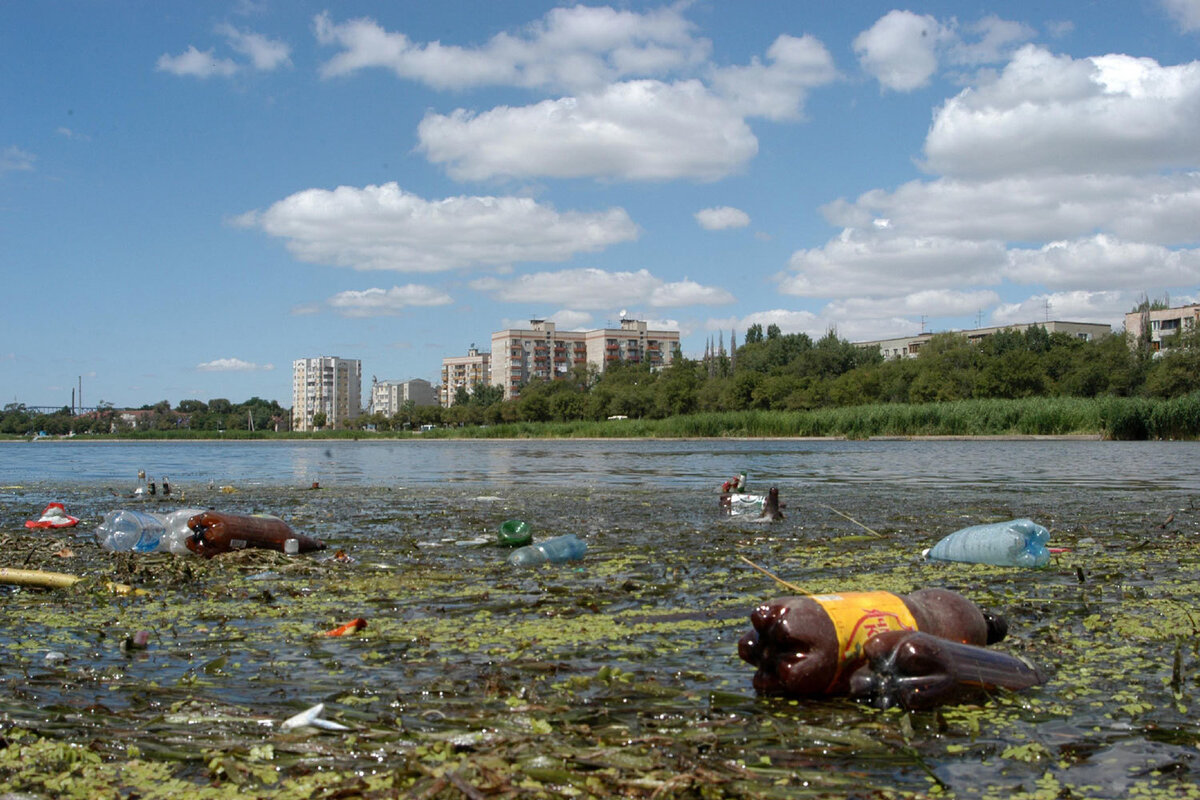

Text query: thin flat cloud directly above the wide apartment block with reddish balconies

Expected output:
[470,269,733,311]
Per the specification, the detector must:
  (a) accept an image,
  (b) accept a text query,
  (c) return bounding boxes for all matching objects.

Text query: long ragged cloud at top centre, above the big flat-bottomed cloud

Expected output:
[313,5,712,89]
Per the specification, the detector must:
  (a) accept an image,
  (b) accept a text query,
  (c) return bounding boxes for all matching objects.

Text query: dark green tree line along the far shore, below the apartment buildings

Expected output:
[0,316,1200,434]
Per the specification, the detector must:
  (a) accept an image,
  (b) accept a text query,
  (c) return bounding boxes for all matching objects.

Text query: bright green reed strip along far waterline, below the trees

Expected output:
[16,392,1200,440]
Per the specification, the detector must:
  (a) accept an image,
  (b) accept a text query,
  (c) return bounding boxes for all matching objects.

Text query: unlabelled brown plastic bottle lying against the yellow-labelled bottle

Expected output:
[850,631,1045,710]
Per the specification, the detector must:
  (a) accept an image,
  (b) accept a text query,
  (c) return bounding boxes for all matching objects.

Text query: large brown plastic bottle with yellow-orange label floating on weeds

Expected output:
[738,589,1008,696]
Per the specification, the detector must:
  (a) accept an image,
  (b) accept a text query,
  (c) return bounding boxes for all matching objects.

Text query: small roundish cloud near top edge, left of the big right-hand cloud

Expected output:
[854,11,952,91]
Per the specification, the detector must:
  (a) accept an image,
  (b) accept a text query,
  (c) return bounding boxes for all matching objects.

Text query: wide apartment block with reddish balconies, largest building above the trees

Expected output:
[492,319,679,399]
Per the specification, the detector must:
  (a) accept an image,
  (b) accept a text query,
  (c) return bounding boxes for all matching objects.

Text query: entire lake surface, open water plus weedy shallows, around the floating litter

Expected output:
[0,439,1200,800]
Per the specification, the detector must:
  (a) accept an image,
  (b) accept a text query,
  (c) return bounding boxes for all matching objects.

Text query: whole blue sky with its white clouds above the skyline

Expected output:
[0,0,1200,407]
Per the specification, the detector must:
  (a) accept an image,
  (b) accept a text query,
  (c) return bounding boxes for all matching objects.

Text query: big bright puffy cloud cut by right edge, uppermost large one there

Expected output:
[925,46,1200,179]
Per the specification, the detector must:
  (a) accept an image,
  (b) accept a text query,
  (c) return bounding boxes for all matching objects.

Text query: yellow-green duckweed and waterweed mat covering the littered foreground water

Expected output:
[0,485,1200,800]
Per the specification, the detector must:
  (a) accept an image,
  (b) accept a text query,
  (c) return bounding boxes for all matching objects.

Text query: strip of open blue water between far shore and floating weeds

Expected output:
[0,439,1200,491]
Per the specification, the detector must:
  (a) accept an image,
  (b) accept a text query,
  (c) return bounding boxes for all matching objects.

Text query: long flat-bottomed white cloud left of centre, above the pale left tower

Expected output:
[234,182,637,272]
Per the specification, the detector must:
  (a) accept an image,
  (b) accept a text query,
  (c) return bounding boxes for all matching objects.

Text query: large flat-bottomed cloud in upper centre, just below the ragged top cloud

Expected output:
[418,80,758,181]
